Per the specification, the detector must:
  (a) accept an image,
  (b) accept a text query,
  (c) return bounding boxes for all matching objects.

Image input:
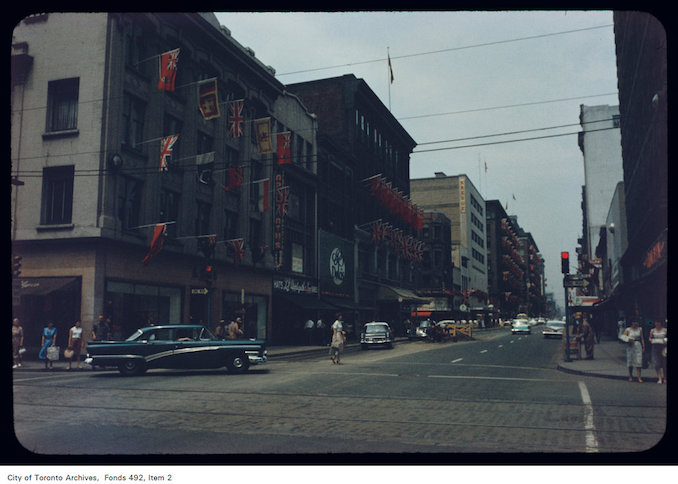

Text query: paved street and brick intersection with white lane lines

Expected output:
[14,332,666,456]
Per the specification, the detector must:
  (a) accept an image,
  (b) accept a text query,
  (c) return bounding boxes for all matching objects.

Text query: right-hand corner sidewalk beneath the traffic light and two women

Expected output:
[558,335,657,383]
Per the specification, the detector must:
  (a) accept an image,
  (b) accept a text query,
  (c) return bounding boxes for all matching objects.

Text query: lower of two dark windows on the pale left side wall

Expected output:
[41,165,75,225]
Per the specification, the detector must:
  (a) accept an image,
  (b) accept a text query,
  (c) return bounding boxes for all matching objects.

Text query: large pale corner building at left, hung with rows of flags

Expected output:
[11,13,317,346]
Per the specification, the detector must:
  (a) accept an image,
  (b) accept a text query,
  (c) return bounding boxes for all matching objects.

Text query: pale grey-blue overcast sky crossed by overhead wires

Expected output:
[215,11,619,314]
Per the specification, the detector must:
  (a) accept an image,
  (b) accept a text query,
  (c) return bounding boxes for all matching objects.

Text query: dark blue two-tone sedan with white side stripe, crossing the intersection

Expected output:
[85,324,267,375]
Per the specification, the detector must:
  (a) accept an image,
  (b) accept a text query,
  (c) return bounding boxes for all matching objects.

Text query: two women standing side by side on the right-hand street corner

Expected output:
[618,318,667,384]
